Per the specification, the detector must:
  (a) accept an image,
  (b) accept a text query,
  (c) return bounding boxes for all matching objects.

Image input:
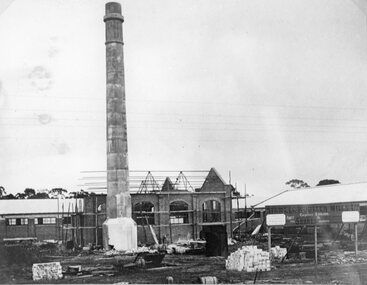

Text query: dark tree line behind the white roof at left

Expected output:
[0,186,95,200]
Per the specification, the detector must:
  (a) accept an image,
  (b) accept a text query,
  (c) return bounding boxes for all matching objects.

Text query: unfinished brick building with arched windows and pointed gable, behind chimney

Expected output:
[73,168,235,246]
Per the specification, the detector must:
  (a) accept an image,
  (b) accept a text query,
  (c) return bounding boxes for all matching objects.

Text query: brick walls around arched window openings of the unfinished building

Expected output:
[77,174,233,245]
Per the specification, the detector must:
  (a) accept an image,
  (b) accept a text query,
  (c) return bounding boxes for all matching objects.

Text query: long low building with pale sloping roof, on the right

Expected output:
[256,182,367,226]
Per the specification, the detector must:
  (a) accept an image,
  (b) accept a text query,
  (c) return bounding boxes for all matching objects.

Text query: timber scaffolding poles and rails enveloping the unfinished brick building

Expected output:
[64,169,253,246]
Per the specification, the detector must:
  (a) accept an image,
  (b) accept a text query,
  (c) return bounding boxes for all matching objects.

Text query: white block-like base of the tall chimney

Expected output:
[102,217,138,251]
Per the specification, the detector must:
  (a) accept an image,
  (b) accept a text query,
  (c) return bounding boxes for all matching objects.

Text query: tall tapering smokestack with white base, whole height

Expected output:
[103,2,137,250]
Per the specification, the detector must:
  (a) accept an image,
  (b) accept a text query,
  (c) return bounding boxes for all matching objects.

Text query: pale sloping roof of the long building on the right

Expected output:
[254,182,367,208]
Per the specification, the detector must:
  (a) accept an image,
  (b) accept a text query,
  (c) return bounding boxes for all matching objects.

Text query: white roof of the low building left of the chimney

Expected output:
[0,199,84,215]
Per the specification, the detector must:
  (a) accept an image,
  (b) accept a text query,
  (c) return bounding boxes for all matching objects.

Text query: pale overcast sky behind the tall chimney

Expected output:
[0,0,367,200]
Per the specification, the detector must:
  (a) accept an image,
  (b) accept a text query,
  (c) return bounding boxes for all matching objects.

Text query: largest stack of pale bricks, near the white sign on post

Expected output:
[226,246,270,272]
